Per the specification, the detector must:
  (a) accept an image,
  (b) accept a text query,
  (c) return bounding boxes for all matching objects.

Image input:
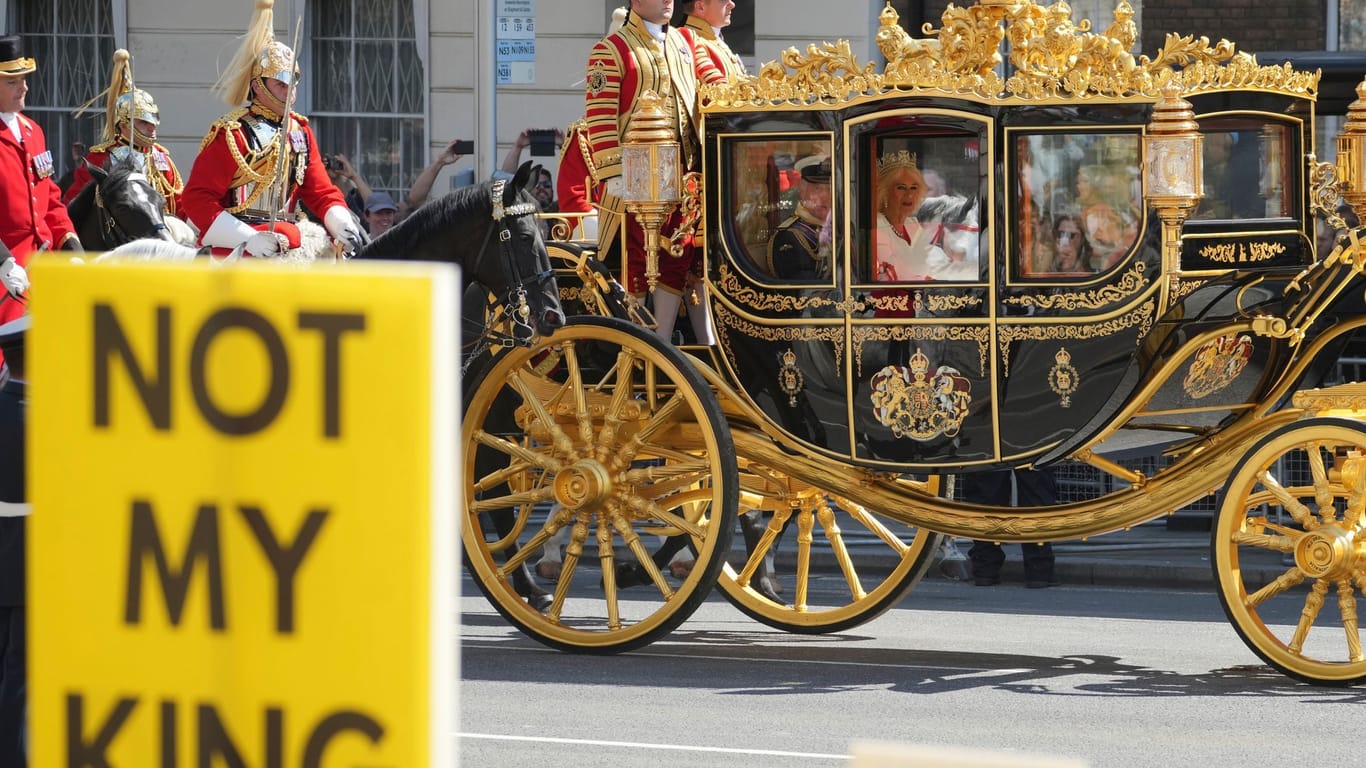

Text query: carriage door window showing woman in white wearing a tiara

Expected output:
[858,127,984,283]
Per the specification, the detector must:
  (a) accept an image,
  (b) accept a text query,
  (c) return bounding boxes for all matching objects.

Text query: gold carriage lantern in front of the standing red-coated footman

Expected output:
[622,90,683,291]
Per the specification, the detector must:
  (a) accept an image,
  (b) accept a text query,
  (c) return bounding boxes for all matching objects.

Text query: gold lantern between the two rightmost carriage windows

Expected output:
[1143,79,1205,276]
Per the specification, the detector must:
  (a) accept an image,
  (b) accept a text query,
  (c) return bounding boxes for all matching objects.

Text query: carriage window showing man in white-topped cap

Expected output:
[725,135,835,283]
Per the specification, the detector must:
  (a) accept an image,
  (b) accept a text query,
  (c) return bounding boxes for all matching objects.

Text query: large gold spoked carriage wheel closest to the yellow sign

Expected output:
[462,317,738,653]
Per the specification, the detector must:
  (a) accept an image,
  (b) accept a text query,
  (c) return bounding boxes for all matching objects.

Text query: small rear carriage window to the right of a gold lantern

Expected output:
[1191,116,1294,220]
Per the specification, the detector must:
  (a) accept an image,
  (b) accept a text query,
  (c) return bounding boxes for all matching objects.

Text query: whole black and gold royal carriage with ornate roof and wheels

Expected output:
[463,0,1366,685]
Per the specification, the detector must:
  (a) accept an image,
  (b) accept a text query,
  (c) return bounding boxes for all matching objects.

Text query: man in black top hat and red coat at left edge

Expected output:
[0,36,82,323]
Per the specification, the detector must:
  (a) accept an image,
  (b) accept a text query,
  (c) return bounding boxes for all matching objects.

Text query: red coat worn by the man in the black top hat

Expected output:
[0,115,76,324]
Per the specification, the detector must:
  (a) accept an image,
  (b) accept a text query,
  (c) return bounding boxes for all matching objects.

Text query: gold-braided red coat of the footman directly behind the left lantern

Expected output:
[585,14,724,294]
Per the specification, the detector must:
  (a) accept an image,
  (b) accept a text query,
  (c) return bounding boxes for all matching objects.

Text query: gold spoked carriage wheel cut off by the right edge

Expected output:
[1213,418,1366,686]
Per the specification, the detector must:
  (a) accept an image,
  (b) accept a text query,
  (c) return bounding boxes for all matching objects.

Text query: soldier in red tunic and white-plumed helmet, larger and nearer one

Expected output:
[182,0,369,257]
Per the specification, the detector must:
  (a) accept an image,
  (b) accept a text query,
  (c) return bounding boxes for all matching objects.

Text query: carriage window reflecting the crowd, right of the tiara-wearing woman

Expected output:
[1012,133,1143,279]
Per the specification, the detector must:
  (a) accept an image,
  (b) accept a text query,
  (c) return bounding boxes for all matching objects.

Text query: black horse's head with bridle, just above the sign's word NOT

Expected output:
[67,153,175,244]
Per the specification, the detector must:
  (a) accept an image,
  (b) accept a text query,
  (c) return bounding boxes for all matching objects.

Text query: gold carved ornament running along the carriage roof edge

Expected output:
[701,0,1320,108]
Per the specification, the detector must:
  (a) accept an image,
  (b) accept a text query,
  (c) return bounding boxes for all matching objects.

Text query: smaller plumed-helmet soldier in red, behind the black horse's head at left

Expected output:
[63,48,184,216]
